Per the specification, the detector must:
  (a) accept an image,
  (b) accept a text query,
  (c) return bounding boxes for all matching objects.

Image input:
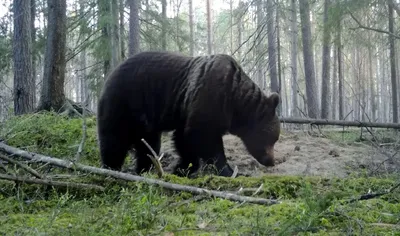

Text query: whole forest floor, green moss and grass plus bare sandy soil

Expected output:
[0,113,400,236]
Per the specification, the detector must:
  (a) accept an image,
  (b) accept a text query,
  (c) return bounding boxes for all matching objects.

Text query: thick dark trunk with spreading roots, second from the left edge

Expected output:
[38,0,67,111]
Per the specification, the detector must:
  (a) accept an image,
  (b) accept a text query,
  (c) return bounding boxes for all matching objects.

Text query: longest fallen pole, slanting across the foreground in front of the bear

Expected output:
[0,143,280,205]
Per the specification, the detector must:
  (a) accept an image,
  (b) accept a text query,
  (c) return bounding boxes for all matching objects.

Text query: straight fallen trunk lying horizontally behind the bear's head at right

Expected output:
[279,117,400,129]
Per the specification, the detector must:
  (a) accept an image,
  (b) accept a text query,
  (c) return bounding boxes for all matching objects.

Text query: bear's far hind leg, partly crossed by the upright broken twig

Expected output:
[134,133,161,174]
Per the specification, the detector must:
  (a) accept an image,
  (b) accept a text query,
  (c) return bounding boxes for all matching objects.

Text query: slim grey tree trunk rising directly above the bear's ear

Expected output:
[267,0,281,93]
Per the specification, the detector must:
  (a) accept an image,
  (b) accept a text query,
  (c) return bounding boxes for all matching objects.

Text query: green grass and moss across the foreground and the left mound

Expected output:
[0,113,400,235]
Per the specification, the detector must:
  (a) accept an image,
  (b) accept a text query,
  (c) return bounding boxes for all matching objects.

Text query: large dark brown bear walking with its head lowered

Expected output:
[97,52,280,176]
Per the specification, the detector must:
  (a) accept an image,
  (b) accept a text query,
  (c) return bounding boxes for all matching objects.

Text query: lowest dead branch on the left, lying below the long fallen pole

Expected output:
[0,174,104,191]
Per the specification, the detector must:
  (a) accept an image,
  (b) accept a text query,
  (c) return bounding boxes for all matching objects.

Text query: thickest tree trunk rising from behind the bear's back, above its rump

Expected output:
[129,0,140,56]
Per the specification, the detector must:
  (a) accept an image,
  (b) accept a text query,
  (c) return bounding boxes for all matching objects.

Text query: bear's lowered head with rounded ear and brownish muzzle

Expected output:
[242,93,280,166]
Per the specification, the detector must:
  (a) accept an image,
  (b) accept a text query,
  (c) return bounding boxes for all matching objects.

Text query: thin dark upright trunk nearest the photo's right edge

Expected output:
[388,1,399,123]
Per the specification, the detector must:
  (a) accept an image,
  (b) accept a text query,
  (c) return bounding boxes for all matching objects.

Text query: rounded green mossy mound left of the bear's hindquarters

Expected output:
[0,112,98,165]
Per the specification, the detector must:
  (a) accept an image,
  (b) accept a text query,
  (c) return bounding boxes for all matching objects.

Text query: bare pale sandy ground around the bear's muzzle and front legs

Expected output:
[135,132,400,177]
